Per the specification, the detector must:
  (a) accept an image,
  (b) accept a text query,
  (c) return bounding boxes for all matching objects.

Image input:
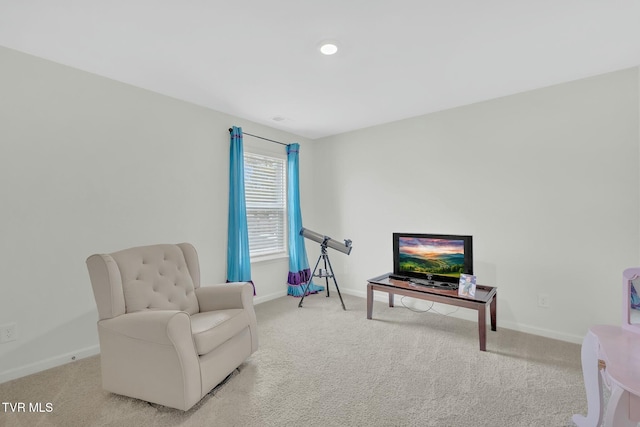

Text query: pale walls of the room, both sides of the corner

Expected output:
[0,43,640,382]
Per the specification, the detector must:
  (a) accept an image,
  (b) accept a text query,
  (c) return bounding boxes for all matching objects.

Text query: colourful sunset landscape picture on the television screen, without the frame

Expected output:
[398,237,464,277]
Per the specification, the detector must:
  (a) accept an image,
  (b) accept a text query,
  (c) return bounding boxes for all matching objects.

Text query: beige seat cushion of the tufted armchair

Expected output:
[191,308,249,356]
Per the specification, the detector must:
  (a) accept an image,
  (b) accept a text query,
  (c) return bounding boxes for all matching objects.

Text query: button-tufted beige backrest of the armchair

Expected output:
[87,243,200,319]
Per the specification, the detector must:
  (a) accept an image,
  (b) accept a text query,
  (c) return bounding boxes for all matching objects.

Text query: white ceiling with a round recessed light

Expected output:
[0,0,640,139]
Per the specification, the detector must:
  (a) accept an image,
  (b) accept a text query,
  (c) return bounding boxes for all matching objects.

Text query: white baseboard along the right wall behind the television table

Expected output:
[341,289,584,344]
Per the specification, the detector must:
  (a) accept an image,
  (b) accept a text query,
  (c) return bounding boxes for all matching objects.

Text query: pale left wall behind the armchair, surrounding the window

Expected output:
[0,47,309,382]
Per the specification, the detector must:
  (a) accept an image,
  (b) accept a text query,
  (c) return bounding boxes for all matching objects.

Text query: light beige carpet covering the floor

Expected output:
[0,292,586,427]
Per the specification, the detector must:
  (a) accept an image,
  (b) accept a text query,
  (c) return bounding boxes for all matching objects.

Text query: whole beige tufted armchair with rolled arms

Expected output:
[87,243,258,411]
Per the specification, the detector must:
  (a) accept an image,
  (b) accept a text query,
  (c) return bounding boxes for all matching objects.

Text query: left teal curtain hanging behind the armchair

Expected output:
[227,126,255,295]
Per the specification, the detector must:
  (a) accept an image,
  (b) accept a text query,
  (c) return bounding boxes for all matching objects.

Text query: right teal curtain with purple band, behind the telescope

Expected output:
[287,143,324,297]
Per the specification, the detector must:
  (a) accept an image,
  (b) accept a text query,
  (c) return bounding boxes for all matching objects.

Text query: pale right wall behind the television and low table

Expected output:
[307,68,640,342]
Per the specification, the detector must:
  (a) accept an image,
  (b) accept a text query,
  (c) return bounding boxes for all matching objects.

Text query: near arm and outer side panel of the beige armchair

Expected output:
[98,310,202,411]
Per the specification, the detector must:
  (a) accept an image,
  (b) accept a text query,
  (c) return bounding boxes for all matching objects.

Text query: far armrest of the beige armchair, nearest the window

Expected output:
[196,282,253,311]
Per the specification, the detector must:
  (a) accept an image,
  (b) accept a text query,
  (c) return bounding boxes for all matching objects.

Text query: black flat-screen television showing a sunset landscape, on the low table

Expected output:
[393,233,473,283]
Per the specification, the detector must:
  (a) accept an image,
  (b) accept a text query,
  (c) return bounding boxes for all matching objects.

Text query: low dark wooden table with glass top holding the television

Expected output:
[367,274,497,351]
